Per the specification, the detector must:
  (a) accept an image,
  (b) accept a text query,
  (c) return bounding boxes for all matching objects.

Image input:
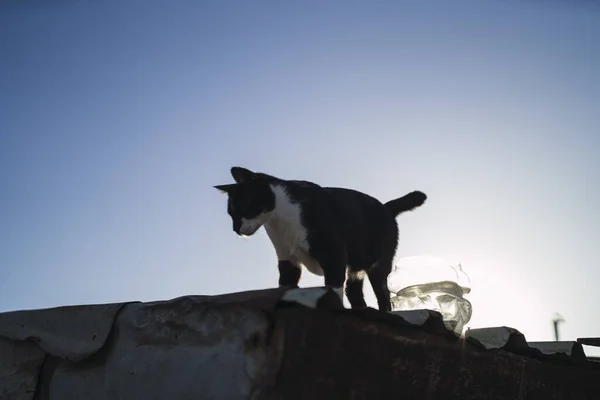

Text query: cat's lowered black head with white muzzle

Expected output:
[215,167,275,236]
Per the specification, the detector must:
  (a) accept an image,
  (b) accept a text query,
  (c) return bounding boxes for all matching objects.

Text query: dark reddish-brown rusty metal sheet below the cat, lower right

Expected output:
[277,307,600,400]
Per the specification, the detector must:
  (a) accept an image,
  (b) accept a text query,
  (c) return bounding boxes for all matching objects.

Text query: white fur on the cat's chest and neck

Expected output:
[265,185,323,276]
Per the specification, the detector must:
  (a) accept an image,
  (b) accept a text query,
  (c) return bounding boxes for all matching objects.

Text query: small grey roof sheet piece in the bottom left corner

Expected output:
[0,338,46,400]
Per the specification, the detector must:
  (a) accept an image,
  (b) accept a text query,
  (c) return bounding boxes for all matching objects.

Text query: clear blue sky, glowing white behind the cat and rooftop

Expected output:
[0,0,600,353]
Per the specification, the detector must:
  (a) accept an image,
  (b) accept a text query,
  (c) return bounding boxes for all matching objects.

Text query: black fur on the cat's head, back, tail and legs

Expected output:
[215,167,427,311]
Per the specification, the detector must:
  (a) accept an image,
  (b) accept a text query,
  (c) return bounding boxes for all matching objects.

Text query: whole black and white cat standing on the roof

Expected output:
[215,167,427,311]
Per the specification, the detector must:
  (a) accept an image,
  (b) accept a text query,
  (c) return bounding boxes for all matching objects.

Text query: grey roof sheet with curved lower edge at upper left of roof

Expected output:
[0,303,124,361]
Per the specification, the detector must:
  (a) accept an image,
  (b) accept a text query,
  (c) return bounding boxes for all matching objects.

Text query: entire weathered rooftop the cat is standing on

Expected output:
[0,288,600,400]
